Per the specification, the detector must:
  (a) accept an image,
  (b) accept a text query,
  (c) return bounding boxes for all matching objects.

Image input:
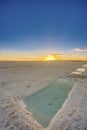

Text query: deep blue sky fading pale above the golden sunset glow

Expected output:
[0,0,87,59]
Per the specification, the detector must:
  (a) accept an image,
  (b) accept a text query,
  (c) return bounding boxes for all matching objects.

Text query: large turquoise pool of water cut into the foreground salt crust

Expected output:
[24,79,74,127]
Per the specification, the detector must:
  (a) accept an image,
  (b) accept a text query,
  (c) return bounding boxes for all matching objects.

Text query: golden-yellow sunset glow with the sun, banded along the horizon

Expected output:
[0,52,87,61]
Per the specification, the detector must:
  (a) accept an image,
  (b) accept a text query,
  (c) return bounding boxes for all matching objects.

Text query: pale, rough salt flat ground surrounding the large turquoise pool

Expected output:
[0,61,87,130]
